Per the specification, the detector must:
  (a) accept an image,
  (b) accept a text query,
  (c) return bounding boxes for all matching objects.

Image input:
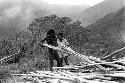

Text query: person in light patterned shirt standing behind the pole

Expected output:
[57,33,69,65]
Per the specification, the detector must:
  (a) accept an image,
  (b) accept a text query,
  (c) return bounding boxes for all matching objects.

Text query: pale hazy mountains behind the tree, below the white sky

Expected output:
[0,0,124,40]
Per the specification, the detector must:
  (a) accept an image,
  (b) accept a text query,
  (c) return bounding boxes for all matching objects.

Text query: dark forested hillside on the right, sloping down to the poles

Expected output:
[68,7,125,57]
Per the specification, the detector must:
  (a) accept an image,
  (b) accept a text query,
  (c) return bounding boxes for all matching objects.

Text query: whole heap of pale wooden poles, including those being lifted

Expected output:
[7,44,125,83]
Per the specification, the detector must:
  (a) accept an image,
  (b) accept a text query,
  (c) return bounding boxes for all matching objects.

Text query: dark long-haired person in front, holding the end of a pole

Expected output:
[41,29,62,70]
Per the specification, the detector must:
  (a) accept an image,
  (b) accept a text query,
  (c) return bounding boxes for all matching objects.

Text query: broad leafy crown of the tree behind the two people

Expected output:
[29,15,71,37]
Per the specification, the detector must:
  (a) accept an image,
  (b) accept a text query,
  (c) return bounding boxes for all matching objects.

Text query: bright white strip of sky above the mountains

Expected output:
[43,0,104,6]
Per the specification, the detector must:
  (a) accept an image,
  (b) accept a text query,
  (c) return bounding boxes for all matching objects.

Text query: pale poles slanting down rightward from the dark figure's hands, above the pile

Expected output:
[43,44,125,70]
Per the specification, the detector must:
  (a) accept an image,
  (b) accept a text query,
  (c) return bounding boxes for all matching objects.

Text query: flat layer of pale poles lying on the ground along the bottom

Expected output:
[11,70,125,83]
